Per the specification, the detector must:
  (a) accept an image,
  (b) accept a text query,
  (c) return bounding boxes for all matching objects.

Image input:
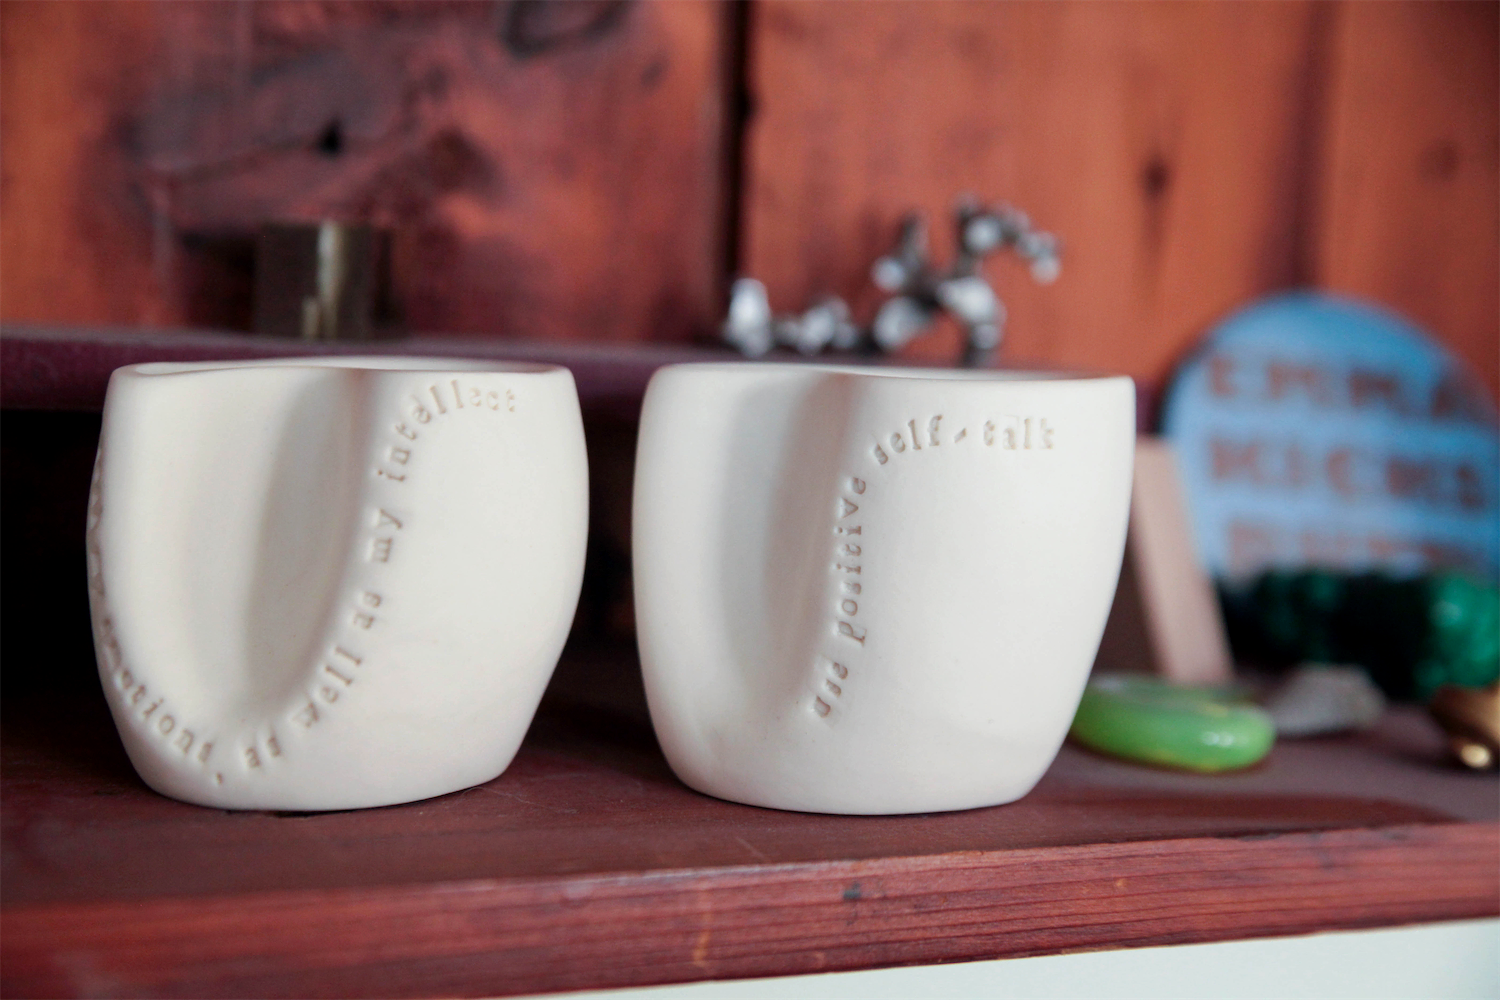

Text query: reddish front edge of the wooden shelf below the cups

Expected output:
[0,823,1500,1000]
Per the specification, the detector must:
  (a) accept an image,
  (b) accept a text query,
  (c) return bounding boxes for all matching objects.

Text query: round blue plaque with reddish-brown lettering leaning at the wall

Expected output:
[1163,294,1500,579]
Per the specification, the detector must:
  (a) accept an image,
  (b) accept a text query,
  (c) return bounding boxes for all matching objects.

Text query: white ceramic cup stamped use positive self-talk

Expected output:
[633,364,1136,813]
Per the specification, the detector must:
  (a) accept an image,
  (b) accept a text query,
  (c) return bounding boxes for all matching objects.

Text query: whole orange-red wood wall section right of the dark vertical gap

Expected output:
[740,0,1500,393]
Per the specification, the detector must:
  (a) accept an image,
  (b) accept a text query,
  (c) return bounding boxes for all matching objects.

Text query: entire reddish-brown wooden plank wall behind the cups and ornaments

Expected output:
[0,0,1500,390]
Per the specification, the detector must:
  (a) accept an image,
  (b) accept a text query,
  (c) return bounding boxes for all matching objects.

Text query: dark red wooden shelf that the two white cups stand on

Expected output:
[0,652,1500,999]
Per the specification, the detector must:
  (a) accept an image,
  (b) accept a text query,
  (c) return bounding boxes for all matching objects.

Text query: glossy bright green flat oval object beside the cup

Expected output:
[1070,675,1277,774]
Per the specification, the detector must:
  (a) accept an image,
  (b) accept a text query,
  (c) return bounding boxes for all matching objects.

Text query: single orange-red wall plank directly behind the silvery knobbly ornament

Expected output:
[741,0,1326,381]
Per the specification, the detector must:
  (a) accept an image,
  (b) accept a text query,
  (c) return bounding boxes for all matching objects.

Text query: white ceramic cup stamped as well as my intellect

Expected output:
[87,357,588,810]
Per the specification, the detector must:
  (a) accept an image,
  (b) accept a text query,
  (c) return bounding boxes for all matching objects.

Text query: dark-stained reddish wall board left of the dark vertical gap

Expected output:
[0,0,726,340]
